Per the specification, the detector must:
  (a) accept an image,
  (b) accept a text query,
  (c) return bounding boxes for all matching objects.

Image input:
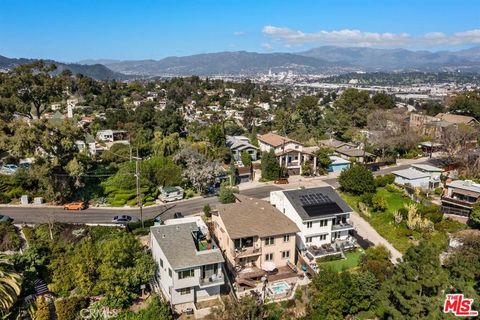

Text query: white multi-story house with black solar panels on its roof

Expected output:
[270,187,356,260]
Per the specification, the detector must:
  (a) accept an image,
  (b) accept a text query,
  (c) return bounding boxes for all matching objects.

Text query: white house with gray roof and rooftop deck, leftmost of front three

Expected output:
[150,217,225,312]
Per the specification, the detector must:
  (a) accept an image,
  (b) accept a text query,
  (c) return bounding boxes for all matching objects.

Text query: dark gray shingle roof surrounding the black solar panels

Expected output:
[282,187,353,221]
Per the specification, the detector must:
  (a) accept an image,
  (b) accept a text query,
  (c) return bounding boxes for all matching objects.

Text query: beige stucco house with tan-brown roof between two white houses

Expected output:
[212,195,299,281]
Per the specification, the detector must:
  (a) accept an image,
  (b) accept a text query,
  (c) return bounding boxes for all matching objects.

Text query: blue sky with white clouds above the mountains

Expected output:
[0,0,480,61]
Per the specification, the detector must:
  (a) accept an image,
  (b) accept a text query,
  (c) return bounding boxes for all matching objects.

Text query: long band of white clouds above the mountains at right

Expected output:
[262,26,480,48]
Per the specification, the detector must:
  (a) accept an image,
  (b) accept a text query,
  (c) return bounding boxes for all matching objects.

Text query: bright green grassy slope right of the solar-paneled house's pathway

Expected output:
[341,188,465,253]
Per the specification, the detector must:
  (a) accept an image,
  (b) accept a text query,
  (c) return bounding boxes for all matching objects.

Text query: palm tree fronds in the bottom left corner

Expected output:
[0,256,22,317]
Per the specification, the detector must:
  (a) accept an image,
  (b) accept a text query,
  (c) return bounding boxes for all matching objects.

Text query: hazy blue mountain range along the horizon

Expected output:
[0,46,480,80]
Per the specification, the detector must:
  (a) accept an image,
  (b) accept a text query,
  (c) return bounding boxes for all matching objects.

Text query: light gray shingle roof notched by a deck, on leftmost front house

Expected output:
[150,222,225,270]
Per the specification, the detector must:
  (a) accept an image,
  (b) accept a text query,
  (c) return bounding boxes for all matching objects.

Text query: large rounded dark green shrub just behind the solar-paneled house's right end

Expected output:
[338,165,376,194]
